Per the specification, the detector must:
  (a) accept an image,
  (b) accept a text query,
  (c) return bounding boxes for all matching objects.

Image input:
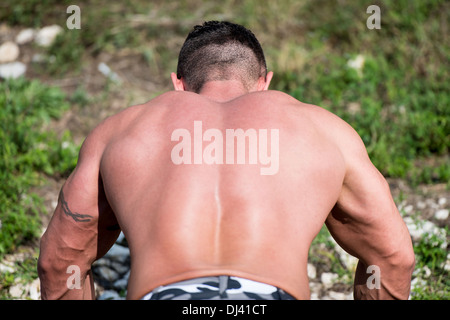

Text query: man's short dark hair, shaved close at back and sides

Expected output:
[177,21,267,93]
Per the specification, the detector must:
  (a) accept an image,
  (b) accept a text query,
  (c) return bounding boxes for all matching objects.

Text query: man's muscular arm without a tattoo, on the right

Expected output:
[326,114,414,299]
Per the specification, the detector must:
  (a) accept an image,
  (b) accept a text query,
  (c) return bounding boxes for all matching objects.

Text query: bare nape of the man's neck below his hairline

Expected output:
[200,80,249,102]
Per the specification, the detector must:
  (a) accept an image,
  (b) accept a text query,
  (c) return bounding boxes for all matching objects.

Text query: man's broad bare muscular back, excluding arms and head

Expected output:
[100,91,345,298]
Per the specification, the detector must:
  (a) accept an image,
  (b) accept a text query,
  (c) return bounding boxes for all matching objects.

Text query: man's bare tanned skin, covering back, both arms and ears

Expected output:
[38,72,414,299]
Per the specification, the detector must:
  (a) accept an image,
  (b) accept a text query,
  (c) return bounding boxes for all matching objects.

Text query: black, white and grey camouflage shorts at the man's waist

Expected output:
[141,276,295,300]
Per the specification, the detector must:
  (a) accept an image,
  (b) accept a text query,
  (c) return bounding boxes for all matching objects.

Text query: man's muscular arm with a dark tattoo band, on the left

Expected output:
[38,125,120,299]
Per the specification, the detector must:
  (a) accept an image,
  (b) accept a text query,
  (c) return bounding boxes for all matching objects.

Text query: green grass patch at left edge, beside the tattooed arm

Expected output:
[0,78,78,257]
